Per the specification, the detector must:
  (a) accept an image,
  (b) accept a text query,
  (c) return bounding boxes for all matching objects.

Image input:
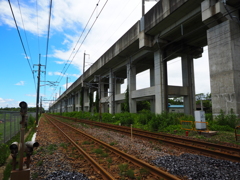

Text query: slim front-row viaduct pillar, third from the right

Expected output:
[127,62,137,113]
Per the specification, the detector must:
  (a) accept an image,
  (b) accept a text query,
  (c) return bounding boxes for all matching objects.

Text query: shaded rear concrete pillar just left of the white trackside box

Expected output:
[182,55,196,115]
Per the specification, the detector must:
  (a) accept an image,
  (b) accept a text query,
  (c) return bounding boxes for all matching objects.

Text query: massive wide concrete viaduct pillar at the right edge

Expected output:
[207,20,240,115]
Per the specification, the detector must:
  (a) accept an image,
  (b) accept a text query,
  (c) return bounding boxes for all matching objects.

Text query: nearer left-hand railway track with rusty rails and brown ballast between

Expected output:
[44,114,179,179]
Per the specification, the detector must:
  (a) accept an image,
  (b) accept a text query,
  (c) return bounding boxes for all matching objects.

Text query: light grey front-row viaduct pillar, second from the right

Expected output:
[154,50,168,114]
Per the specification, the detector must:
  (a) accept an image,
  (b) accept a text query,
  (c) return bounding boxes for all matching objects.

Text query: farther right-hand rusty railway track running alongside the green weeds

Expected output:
[50,116,240,162]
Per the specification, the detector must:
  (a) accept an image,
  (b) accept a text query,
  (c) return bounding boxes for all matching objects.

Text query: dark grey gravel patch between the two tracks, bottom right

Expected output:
[152,153,240,180]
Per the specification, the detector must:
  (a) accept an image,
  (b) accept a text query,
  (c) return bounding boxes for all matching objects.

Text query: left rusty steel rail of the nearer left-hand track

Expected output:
[45,115,114,180]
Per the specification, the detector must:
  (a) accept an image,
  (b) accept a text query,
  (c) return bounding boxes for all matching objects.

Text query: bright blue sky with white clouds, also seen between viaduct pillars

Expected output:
[0,0,210,109]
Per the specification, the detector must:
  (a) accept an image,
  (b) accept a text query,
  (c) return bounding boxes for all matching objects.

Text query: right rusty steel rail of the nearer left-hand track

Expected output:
[45,114,179,180]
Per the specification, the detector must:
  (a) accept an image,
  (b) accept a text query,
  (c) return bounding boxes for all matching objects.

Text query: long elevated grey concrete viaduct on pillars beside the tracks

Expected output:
[50,0,240,115]
